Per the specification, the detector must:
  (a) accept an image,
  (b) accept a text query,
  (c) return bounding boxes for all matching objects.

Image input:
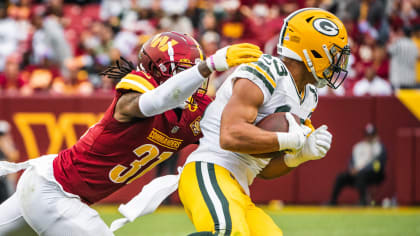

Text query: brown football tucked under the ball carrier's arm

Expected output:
[253,112,300,158]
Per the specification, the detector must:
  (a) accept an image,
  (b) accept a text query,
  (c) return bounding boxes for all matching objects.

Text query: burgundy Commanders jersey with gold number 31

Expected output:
[53,72,211,204]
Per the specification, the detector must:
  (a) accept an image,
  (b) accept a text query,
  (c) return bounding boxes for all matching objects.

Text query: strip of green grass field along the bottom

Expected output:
[95,206,420,236]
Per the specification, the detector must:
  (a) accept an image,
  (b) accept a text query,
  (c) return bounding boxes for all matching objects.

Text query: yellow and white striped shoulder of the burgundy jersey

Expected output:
[115,71,158,93]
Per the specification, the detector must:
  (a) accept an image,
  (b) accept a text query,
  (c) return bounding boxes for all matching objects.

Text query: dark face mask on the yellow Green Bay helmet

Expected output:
[323,45,350,89]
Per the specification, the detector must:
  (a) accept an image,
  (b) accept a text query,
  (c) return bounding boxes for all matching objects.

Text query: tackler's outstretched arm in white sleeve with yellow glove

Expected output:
[114,43,262,122]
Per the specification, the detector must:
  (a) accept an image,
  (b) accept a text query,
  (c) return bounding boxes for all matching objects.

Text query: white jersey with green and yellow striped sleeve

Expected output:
[186,54,318,195]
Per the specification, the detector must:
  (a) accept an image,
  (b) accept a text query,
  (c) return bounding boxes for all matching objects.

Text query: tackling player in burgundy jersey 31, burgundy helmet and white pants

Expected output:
[0,32,262,235]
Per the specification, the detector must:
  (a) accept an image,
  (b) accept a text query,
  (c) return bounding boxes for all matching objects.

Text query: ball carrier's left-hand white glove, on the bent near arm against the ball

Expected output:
[277,112,305,153]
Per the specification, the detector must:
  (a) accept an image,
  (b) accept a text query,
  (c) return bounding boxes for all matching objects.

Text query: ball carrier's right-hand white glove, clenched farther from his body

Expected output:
[284,125,332,167]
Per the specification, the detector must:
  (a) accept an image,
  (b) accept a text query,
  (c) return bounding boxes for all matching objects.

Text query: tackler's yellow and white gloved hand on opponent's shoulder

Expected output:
[206,43,263,72]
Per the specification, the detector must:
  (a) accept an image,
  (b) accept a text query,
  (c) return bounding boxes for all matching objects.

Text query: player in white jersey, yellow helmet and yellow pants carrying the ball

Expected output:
[179,8,350,236]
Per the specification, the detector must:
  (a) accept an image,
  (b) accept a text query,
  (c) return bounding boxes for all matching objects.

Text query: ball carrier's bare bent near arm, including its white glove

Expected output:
[220,78,305,154]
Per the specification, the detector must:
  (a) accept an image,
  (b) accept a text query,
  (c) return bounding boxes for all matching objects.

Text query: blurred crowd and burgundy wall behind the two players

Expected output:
[0,0,420,206]
